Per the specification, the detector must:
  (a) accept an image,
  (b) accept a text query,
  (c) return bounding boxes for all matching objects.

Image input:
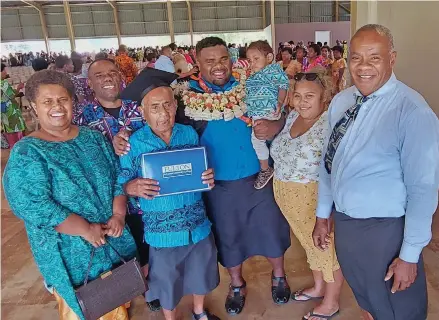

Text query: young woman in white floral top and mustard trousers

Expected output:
[271,67,343,320]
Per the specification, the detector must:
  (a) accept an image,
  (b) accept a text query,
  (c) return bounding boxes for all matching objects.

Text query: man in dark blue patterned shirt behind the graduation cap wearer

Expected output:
[74,59,160,311]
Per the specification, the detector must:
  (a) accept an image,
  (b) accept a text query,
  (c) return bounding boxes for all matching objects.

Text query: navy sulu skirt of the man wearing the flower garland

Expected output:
[204,175,291,268]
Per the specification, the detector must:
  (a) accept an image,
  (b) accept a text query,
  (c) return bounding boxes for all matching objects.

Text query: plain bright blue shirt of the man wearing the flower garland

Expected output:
[190,77,260,180]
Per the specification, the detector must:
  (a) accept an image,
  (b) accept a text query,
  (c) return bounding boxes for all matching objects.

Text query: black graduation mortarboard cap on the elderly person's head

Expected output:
[120,68,178,102]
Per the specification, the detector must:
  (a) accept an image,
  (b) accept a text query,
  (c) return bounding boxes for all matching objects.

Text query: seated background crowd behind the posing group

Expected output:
[2,40,347,150]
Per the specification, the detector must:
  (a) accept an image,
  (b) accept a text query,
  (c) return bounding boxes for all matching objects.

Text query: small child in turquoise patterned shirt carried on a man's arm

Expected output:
[245,40,289,189]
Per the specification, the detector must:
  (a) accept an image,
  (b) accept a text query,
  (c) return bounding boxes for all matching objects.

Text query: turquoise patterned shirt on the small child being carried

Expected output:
[245,63,290,117]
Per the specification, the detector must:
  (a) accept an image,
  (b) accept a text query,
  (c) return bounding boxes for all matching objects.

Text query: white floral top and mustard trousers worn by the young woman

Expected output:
[271,112,340,282]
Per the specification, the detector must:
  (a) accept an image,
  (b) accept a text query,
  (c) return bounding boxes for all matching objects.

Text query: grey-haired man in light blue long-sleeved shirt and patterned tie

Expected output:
[313,25,439,320]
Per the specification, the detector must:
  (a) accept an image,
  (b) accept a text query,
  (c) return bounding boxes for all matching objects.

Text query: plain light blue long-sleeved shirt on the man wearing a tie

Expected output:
[317,75,439,263]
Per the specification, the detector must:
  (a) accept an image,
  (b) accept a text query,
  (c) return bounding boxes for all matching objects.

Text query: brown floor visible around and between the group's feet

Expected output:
[1,150,439,320]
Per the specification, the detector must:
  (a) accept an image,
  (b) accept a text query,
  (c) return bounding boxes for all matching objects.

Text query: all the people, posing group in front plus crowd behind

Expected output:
[2,25,439,320]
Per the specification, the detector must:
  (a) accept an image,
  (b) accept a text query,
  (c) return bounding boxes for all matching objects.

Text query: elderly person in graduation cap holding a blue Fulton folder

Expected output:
[119,68,219,320]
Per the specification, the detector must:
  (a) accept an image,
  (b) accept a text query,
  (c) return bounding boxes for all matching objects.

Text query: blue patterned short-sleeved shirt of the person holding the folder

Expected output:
[118,123,211,248]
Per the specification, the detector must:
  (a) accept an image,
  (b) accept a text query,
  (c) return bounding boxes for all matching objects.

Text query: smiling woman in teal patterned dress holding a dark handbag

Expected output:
[3,70,136,320]
